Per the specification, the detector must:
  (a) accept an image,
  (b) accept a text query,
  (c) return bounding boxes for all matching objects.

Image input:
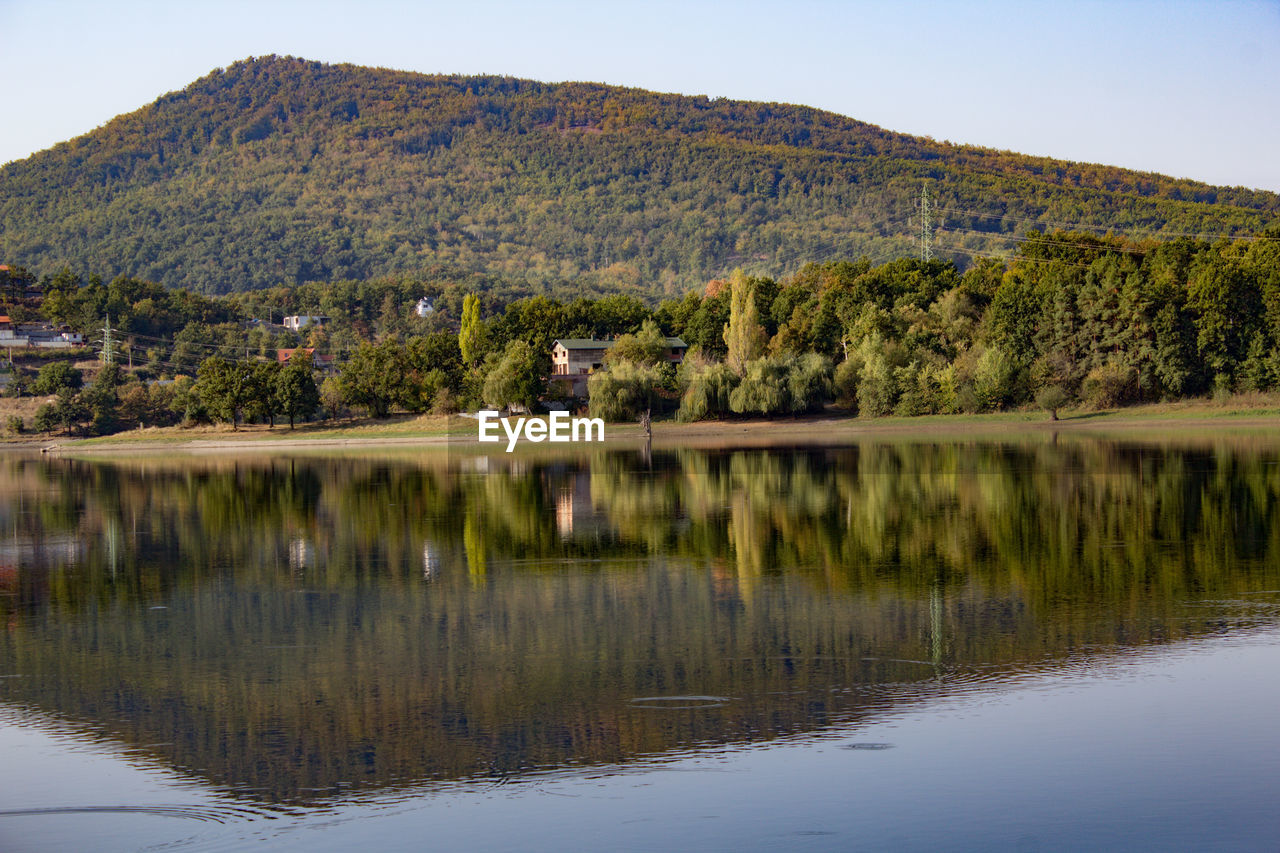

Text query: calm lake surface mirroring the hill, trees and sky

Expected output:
[0,433,1280,853]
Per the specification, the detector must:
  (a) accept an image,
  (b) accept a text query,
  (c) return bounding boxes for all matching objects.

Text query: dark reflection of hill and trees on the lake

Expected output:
[0,442,1280,800]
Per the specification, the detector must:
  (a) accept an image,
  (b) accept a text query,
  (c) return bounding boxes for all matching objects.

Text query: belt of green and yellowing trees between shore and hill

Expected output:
[2,228,1280,432]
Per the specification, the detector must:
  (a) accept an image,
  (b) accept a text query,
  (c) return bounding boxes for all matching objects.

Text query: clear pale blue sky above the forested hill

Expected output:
[0,0,1280,191]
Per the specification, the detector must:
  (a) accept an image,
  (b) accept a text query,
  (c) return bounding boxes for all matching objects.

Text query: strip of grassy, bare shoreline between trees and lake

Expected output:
[10,400,1280,455]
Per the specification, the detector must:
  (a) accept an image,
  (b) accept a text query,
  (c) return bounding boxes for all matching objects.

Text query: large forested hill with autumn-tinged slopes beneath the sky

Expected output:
[0,56,1280,293]
